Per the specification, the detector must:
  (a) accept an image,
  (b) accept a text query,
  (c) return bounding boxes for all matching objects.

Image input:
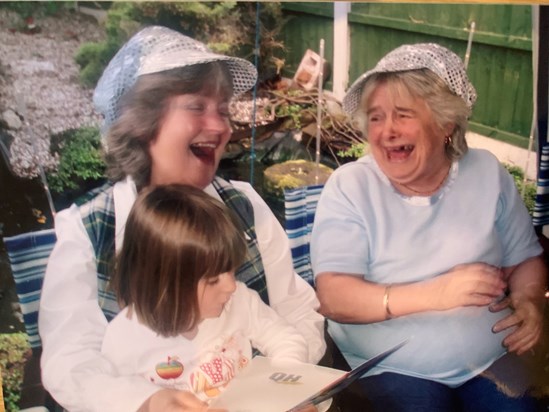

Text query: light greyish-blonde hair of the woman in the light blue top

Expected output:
[357,69,471,160]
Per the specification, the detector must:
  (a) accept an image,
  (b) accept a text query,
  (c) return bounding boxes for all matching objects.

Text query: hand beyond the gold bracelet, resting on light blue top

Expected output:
[429,263,507,310]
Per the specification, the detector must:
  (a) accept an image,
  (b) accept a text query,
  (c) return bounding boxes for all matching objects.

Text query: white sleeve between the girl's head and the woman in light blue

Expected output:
[231,181,326,363]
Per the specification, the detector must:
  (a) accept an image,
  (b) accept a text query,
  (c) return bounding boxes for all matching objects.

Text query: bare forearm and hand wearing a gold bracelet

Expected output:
[316,263,506,323]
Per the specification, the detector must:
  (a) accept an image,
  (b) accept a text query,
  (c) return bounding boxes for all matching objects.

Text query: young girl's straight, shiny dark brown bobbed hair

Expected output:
[111,184,247,337]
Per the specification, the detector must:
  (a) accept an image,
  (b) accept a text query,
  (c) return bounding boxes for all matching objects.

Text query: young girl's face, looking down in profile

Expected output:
[198,271,236,320]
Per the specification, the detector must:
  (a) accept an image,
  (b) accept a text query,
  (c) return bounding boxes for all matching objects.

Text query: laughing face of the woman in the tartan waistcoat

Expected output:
[149,94,231,189]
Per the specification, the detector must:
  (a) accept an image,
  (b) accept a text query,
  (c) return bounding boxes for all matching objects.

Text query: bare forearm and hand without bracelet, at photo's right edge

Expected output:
[490,257,547,355]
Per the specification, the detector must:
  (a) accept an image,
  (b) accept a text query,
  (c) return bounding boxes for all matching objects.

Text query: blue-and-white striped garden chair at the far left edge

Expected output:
[4,229,58,412]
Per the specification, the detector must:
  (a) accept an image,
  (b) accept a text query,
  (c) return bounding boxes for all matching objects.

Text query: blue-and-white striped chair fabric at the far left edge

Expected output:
[4,229,56,348]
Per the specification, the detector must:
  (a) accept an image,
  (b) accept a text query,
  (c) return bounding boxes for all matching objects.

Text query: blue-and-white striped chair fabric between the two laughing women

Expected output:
[284,185,324,286]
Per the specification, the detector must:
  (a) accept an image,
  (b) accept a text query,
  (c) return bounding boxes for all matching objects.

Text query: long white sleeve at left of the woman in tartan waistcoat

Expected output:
[39,206,158,411]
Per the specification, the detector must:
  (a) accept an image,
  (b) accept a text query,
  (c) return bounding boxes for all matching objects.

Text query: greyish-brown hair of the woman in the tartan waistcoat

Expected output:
[105,62,233,188]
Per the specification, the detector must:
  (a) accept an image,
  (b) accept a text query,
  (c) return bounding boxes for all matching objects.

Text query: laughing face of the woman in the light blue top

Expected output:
[366,83,448,184]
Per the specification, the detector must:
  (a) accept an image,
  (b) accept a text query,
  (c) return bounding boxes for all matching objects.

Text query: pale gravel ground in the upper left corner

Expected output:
[0,9,104,177]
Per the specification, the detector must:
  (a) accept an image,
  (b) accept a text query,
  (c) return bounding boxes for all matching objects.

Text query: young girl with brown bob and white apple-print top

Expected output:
[102,185,308,408]
